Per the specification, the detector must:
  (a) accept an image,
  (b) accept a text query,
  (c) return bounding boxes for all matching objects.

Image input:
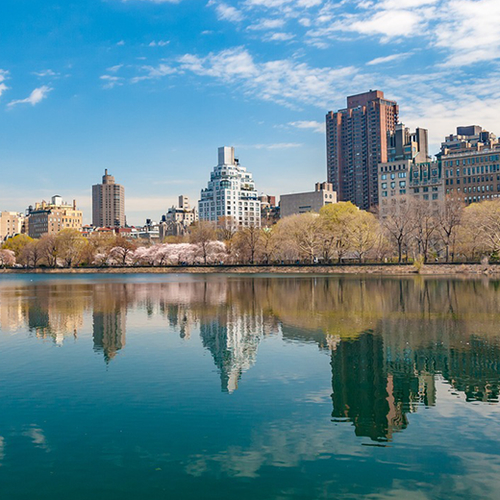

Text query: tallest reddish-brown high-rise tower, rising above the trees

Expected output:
[326,90,399,210]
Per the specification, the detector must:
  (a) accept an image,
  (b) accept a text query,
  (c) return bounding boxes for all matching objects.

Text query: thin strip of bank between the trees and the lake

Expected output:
[0,264,500,276]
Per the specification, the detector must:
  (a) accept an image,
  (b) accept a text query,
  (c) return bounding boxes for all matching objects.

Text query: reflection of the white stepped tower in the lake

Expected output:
[200,310,264,393]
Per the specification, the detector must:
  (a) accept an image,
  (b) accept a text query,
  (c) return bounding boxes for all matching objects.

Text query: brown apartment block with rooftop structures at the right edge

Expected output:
[438,126,500,205]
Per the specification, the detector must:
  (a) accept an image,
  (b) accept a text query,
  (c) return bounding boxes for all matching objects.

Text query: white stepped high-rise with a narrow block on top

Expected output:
[198,147,260,227]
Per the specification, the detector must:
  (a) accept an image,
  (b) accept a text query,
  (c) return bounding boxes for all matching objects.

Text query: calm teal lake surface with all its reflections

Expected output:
[0,275,500,500]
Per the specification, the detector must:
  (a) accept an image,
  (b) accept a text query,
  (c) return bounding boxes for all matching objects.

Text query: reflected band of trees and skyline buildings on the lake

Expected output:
[0,276,500,410]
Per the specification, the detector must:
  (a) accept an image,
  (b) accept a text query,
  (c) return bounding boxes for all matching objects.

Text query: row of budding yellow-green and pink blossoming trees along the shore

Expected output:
[0,198,500,268]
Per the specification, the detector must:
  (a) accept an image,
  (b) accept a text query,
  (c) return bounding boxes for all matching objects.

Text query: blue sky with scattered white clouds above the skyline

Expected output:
[0,0,500,224]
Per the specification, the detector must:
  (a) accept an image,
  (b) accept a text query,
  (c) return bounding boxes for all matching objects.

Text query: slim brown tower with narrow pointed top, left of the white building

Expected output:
[92,169,126,227]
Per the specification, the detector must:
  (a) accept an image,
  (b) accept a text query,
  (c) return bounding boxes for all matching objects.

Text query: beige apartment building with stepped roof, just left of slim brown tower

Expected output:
[28,195,83,238]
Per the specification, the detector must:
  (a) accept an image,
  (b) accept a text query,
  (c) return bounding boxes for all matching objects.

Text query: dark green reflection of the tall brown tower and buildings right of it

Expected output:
[331,325,500,441]
